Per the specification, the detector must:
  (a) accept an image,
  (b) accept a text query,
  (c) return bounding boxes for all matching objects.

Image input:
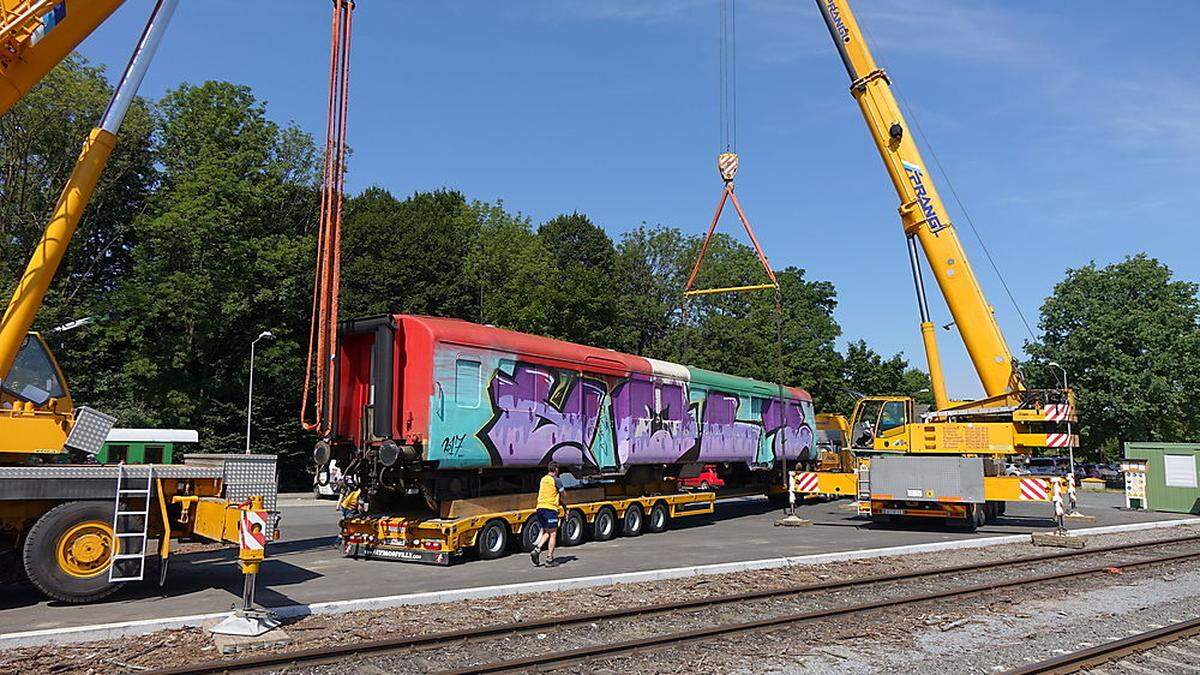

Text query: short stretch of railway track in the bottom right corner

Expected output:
[1006,617,1200,675]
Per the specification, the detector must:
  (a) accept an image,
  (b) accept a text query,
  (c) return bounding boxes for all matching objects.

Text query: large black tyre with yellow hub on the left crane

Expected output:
[23,501,120,603]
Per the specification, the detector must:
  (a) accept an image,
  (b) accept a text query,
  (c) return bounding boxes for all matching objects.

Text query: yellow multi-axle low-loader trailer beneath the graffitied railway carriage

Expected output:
[341,485,716,566]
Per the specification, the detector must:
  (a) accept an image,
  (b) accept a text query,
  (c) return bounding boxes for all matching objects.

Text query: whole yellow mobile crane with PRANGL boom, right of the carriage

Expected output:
[800,0,1078,526]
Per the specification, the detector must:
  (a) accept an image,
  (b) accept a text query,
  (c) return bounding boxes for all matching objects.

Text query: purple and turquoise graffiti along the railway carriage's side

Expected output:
[441,353,814,471]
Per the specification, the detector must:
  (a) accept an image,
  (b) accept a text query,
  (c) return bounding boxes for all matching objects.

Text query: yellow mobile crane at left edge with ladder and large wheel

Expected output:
[0,0,276,603]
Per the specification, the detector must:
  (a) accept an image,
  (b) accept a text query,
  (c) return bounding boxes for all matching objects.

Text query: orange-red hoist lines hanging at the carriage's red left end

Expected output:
[300,0,354,437]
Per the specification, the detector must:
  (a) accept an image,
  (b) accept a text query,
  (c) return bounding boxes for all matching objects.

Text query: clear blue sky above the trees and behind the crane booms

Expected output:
[83,0,1200,396]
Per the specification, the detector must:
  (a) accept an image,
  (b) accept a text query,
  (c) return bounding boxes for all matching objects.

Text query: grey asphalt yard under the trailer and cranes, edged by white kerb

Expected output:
[0,485,1181,633]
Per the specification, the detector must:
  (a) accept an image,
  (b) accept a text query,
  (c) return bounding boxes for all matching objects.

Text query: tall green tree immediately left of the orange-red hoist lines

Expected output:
[89,82,317,482]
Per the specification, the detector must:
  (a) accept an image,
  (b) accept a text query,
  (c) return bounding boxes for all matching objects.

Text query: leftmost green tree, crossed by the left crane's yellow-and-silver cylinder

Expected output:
[0,55,156,329]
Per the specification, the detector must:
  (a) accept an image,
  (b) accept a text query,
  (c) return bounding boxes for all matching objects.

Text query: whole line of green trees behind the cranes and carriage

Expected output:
[0,56,1200,483]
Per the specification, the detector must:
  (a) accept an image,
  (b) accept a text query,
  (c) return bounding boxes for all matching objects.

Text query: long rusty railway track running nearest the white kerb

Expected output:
[145,536,1200,675]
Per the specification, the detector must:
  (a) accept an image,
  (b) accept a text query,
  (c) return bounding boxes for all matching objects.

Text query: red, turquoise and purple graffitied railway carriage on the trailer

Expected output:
[328,315,815,501]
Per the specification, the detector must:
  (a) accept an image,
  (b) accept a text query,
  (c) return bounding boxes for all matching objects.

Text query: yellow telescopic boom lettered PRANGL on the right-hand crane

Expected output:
[816,0,1025,410]
